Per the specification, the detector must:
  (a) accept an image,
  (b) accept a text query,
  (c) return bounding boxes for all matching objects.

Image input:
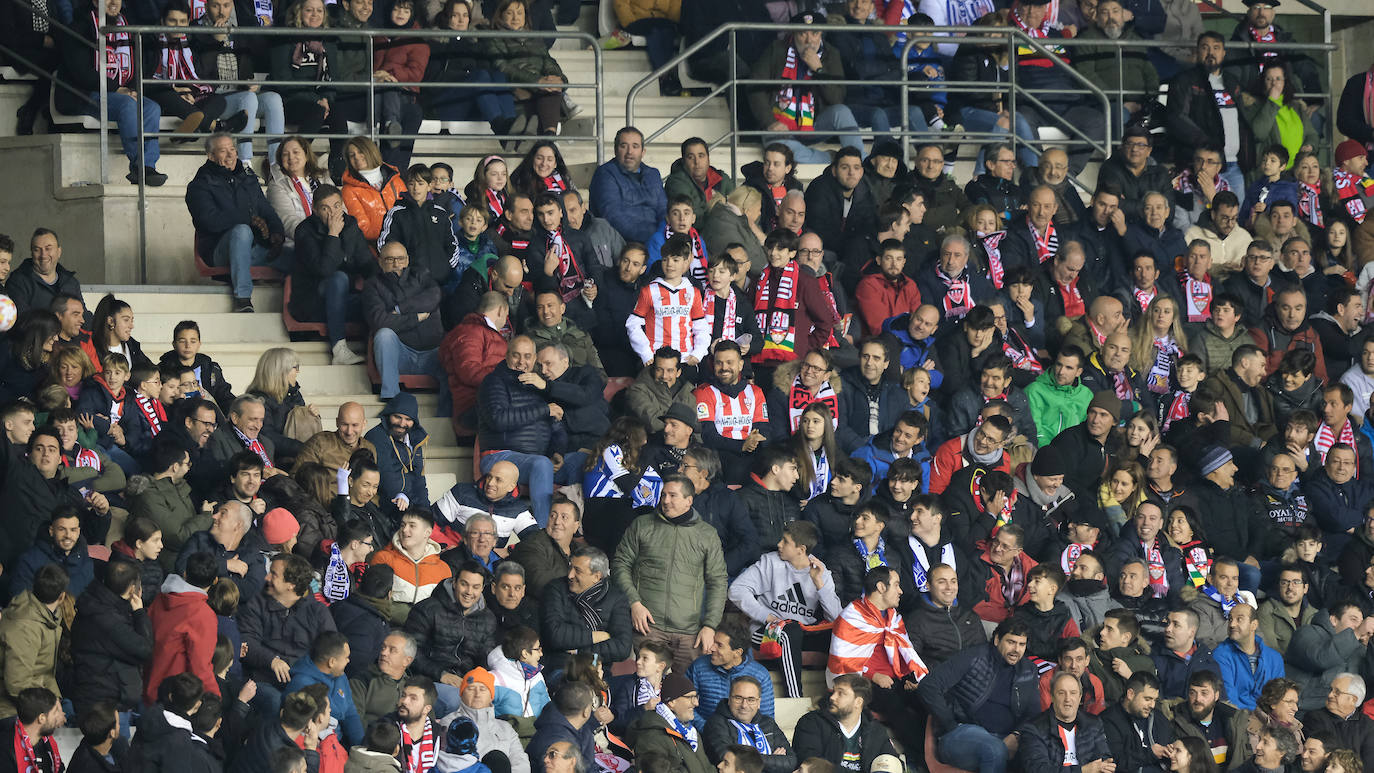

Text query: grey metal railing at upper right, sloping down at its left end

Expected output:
[625,20,1336,176]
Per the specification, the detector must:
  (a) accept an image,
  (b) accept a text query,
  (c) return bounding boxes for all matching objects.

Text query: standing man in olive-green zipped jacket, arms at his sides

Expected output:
[611,475,727,667]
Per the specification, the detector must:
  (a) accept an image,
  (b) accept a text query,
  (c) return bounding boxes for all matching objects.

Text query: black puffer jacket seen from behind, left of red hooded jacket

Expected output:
[67,584,153,713]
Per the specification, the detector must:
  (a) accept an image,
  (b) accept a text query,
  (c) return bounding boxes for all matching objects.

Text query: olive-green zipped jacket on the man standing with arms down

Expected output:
[610,509,728,634]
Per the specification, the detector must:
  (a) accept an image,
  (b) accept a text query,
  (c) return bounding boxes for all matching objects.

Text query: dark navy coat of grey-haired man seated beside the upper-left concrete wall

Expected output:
[185,161,286,257]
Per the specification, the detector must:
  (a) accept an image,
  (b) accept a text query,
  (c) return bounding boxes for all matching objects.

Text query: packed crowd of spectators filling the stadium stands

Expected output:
[0,0,1374,773]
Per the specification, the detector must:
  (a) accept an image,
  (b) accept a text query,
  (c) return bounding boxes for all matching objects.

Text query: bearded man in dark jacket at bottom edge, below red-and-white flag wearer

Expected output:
[793,674,896,773]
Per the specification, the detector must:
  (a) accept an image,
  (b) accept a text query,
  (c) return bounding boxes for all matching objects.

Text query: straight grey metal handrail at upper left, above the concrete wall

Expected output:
[99,21,606,281]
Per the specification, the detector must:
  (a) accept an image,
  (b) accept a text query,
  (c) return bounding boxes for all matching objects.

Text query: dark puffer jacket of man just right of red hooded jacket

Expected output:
[239,593,334,684]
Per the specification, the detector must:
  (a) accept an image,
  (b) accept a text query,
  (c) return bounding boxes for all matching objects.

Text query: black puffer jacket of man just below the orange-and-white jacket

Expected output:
[405,578,497,680]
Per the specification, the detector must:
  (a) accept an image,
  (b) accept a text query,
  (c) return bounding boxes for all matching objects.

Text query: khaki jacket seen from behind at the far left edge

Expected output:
[0,590,62,719]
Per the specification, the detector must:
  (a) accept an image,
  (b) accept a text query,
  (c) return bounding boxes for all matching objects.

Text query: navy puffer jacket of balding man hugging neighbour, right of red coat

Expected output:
[477,362,554,454]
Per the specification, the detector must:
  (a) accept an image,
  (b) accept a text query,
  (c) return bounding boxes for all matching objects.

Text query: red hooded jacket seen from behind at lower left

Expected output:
[143,574,220,704]
